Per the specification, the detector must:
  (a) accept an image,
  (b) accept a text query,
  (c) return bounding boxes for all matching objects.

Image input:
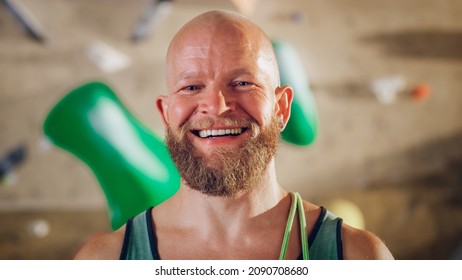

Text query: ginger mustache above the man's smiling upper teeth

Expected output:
[179,117,259,139]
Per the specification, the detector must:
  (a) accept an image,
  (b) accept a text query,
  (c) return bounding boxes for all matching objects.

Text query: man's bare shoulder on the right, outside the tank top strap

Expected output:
[342,224,393,260]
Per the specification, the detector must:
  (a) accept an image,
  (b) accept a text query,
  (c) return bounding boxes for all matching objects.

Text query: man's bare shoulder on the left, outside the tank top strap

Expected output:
[74,226,125,260]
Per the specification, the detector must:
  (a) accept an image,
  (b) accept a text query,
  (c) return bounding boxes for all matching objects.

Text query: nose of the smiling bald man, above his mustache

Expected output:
[200,88,234,116]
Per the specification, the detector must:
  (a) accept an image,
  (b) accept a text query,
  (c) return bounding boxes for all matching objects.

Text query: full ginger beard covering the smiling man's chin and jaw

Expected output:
[165,116,280,197]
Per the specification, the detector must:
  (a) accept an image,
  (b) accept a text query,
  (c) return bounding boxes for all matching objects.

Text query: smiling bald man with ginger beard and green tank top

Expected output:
[76,11,392,260]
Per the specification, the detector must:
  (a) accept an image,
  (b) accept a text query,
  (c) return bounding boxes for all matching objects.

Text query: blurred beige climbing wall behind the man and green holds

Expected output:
[0,0,462,259]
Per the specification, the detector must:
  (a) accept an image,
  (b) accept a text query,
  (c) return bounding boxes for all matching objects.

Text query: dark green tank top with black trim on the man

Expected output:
[120,196,343,260]
